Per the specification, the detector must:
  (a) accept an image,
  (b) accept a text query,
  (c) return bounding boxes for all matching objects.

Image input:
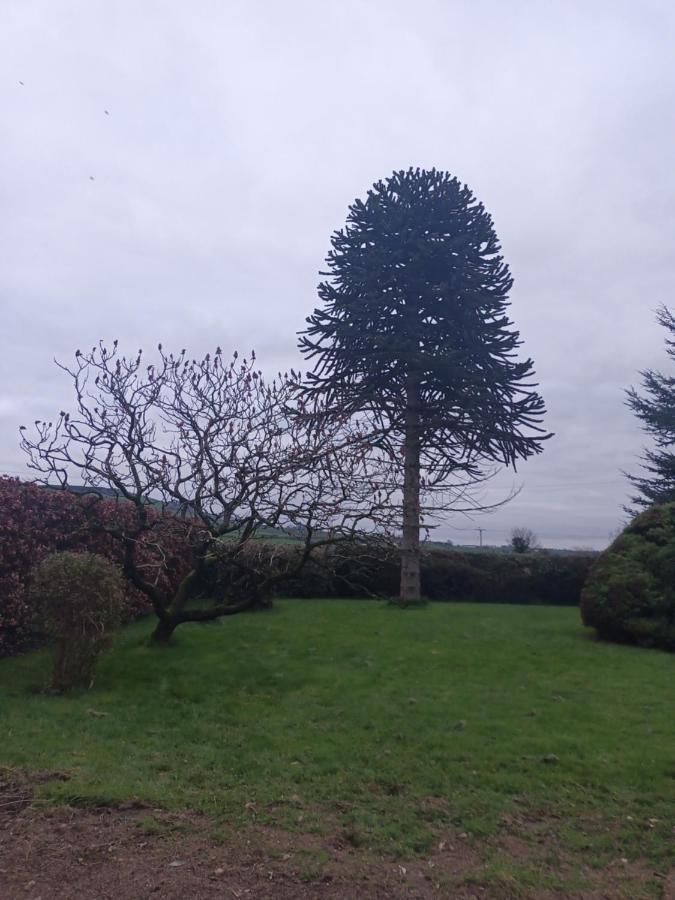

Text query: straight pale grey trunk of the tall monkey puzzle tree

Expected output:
[400,372,422,606]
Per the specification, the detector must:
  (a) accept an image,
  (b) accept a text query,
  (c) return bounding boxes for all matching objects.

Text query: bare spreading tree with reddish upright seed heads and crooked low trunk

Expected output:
[22,342,395,641]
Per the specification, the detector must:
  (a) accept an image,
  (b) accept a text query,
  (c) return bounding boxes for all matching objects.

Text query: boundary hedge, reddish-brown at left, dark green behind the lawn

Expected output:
[0,477,595,656]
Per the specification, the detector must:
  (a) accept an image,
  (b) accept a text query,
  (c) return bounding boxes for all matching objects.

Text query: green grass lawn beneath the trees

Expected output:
[0,600,675,885]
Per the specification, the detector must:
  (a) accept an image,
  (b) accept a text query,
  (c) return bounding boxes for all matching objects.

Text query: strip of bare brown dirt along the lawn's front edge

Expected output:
[0,772,675,900]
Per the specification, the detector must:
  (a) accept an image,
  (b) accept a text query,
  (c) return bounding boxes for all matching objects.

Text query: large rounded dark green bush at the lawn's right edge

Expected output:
[581,503,675,651]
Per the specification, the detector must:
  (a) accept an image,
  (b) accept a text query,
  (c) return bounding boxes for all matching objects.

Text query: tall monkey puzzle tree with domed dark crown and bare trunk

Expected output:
[300,169,545,604]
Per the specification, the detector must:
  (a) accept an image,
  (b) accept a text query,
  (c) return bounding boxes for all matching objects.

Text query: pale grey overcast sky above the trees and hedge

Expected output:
[0,0,675,547]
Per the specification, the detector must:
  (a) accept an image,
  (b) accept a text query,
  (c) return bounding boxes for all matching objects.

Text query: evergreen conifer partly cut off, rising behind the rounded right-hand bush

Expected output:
[626,306,675,515]
